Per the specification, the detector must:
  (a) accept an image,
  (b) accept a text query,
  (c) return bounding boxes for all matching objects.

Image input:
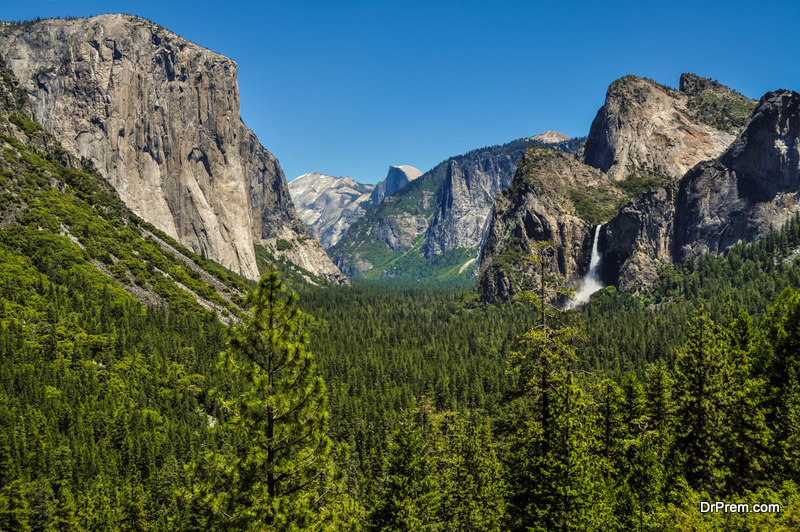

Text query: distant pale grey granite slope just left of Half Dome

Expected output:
[289,172,375,249]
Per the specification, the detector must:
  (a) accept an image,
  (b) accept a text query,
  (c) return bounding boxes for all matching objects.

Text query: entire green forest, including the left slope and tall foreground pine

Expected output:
[0,55,800,531]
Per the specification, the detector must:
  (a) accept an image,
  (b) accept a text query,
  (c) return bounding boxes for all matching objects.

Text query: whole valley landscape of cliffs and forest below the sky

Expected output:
[0,9,800,531]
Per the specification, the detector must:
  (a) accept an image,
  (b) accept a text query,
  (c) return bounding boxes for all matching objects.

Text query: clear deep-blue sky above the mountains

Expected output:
[0,0,800,182]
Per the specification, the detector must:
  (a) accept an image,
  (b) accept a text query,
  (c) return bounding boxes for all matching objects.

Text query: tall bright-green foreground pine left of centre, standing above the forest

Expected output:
[189,270,352,530]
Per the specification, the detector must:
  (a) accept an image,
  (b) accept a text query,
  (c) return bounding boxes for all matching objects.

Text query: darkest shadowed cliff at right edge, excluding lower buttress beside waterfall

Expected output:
[675,90,800,260]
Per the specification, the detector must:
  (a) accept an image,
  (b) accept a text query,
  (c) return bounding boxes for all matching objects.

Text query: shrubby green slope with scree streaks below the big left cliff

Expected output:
[0,54,246,321]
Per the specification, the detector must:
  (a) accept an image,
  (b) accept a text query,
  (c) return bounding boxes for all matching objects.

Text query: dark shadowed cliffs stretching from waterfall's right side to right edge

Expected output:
[601,90,800,290]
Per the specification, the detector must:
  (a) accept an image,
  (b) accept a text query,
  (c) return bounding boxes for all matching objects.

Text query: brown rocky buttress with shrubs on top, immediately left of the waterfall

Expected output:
[478,146,616,301]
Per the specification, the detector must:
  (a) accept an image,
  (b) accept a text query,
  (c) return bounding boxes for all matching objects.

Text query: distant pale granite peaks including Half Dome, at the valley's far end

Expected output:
[289,165,422,249]
